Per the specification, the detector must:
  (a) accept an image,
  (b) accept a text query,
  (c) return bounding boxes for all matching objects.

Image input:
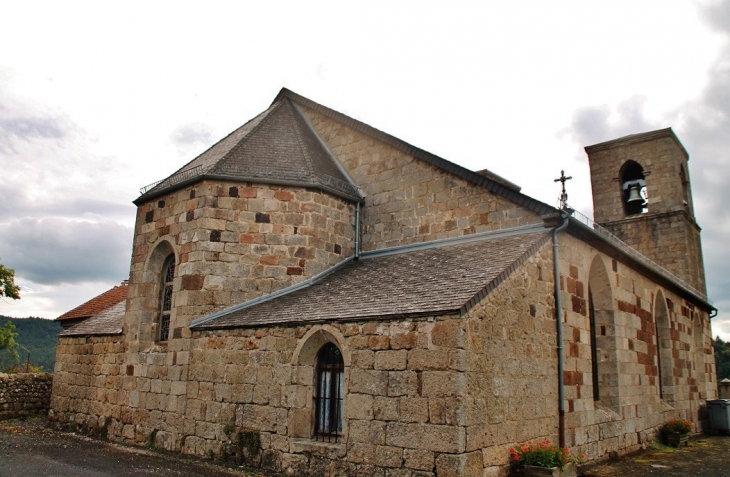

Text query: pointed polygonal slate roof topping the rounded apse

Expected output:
[134,98,362,204]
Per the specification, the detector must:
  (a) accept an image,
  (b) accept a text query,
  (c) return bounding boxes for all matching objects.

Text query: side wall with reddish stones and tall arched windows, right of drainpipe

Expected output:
[560,234,717,459]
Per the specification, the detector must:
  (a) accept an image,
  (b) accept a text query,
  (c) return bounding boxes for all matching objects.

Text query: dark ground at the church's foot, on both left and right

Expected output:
[0,418,730,477]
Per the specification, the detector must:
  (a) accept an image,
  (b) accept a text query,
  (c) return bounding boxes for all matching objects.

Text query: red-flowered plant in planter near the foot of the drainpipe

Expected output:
[509,439,583,477]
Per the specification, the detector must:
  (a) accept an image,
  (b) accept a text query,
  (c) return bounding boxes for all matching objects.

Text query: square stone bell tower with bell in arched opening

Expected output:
[585,128,706,293]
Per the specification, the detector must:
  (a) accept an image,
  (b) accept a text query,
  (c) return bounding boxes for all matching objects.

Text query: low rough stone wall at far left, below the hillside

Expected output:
[0,373,53,419]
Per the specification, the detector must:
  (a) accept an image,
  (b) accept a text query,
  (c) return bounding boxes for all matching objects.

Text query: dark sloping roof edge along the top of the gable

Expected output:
[273,88,556,215]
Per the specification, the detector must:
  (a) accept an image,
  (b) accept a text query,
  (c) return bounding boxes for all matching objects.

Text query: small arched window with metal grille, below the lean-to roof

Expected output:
[314,343,345,442]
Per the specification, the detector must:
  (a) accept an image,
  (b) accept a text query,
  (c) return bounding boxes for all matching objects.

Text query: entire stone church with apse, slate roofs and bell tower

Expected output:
[50,89,717,477]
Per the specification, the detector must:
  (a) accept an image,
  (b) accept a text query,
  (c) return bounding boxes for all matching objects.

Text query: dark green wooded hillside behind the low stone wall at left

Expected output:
[0,316,62,373]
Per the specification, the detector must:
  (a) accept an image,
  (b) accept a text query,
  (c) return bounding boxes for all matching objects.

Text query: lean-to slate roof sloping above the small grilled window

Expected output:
[191,225,550,329]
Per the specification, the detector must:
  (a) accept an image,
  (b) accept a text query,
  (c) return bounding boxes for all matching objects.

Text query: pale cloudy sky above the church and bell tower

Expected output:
[0,0,730,339]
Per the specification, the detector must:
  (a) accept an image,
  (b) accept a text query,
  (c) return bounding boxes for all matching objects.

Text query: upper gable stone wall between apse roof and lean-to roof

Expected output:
[300,106,540,250]
